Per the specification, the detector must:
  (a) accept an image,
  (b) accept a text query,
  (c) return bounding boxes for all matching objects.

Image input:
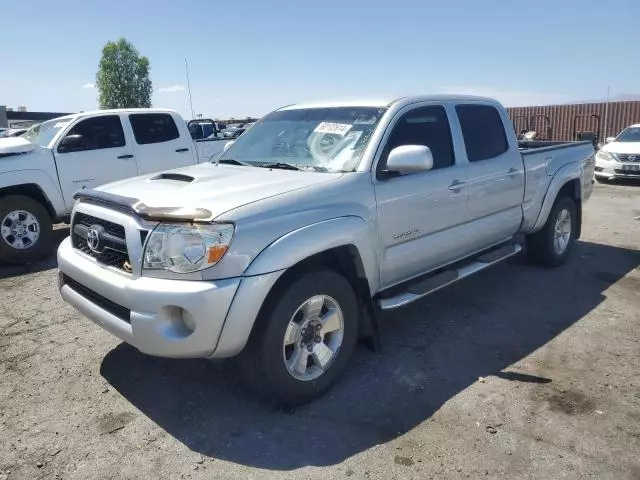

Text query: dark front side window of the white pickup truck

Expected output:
[58,115,125,153]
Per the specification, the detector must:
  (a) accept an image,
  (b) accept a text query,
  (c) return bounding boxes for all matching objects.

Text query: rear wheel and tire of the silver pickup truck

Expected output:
[526,197,578,267]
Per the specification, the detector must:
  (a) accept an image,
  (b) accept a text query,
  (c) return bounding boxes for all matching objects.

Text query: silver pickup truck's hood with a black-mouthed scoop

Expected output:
[96,163,343,219]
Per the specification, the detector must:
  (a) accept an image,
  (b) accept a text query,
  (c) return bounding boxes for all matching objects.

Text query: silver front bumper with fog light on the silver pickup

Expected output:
[58,238,280,358]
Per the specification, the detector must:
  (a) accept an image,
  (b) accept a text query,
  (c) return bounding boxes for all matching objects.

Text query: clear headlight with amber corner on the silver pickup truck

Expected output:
[142,223,234,273]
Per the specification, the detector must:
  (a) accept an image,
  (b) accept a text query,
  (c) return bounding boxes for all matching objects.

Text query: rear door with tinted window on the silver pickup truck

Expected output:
[455,103,524,250]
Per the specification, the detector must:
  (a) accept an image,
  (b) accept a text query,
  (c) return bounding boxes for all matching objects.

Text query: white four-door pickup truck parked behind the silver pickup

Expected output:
[0,109,229,263]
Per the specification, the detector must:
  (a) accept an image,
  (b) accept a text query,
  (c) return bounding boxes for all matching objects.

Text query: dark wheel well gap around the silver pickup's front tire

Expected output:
[252,245,377,348]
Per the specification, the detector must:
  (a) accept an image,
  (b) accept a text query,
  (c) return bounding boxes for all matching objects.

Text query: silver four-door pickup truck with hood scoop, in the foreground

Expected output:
[58,96,594,405]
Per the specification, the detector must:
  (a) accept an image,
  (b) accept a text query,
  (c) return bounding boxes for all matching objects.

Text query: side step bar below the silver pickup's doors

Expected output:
[378,244,522,310]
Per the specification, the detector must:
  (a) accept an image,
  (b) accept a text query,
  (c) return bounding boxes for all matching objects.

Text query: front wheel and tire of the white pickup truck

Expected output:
[0,195,53,264]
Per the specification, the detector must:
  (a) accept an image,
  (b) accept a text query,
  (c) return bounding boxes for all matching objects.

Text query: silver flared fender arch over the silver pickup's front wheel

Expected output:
[244,216,379,293]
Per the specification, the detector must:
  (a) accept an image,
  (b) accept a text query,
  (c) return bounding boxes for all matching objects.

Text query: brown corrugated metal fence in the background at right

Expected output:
[507,101,640,141]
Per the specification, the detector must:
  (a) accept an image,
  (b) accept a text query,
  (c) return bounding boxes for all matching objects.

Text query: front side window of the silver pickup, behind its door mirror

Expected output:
[378,105,455,170]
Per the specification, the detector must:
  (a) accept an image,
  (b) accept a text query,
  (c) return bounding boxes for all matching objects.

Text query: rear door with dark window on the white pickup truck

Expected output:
[127,112,195,175]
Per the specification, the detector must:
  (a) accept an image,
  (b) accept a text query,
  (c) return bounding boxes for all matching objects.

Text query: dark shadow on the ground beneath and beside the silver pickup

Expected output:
[101,242,640,470]
